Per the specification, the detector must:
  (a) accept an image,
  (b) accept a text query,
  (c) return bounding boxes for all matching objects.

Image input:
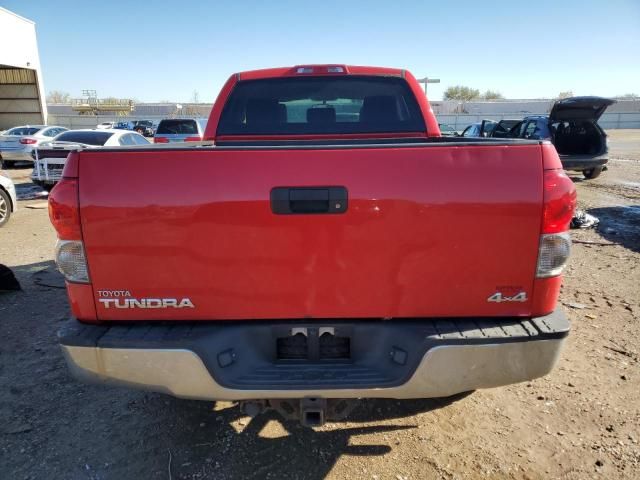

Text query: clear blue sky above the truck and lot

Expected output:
[0,0,640,102]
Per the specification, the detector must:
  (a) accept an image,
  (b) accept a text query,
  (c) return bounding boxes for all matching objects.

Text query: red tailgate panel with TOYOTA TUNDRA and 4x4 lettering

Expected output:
[79,144,542,320]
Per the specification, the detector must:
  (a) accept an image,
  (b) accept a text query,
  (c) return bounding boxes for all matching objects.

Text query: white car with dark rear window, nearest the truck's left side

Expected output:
[31,129,150,190]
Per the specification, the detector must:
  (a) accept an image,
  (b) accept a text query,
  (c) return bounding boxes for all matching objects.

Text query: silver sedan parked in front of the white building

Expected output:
[0,125,67,168]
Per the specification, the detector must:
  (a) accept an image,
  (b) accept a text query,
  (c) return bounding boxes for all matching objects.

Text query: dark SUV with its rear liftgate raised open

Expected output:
[510,97,615,179]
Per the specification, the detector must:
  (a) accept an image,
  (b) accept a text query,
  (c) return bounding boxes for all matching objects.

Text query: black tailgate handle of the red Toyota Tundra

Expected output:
[271,187,348,215]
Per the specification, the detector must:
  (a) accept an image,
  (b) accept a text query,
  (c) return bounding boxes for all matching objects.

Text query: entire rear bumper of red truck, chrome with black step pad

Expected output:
[59,310,569,400]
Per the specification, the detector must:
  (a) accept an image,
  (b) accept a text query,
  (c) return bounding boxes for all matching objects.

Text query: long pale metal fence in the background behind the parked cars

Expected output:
[49,112,640,130]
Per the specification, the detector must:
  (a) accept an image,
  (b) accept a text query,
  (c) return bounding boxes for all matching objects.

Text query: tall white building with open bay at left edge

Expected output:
[0,7,47,130]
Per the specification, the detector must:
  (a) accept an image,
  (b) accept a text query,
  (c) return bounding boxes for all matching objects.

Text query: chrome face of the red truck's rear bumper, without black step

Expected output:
[62,339,564,400]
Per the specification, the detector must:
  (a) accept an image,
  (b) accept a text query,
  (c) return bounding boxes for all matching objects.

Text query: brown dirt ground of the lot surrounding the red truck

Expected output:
[0,130,640,480]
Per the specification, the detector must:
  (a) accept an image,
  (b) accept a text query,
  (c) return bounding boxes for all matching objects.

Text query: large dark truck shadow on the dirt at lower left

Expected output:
[0,261,476,479]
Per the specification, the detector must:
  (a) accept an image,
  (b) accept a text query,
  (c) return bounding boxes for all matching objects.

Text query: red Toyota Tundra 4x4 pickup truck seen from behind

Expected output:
[49,65,576,425]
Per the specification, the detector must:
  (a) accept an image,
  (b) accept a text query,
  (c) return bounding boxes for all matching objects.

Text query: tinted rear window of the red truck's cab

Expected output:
[217,76,426,135]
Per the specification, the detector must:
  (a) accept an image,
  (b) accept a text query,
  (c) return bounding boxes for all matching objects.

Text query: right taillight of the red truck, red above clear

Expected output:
[536,169,576,278]
